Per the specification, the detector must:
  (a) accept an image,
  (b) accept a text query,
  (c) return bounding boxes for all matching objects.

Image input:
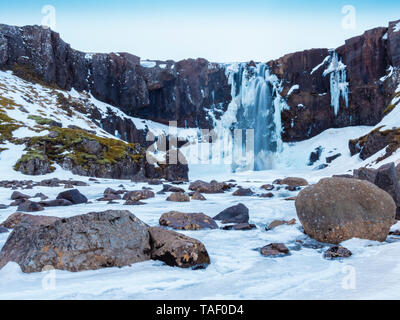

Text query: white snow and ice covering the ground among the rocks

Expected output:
[0,65,400,300]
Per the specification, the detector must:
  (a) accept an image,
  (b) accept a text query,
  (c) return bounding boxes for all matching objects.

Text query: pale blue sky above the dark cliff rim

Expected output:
[0,0,400,62]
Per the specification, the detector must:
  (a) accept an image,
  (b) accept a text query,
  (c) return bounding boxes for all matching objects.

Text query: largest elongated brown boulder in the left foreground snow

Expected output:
[0,210,150,273]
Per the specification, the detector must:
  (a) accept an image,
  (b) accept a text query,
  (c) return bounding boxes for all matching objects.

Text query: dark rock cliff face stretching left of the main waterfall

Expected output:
[0,25,231,129]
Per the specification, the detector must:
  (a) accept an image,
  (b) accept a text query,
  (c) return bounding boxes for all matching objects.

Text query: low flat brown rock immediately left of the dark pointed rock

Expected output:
[159,211,218,230]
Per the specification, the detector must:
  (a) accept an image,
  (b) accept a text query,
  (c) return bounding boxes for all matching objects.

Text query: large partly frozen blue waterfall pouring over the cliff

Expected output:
[215,63,287,171]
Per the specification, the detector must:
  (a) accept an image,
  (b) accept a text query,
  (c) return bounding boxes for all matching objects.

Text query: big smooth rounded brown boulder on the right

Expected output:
[296,178,396,244]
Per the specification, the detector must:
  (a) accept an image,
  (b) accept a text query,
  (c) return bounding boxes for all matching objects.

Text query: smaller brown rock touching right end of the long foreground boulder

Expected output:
[149,227,210,269]
